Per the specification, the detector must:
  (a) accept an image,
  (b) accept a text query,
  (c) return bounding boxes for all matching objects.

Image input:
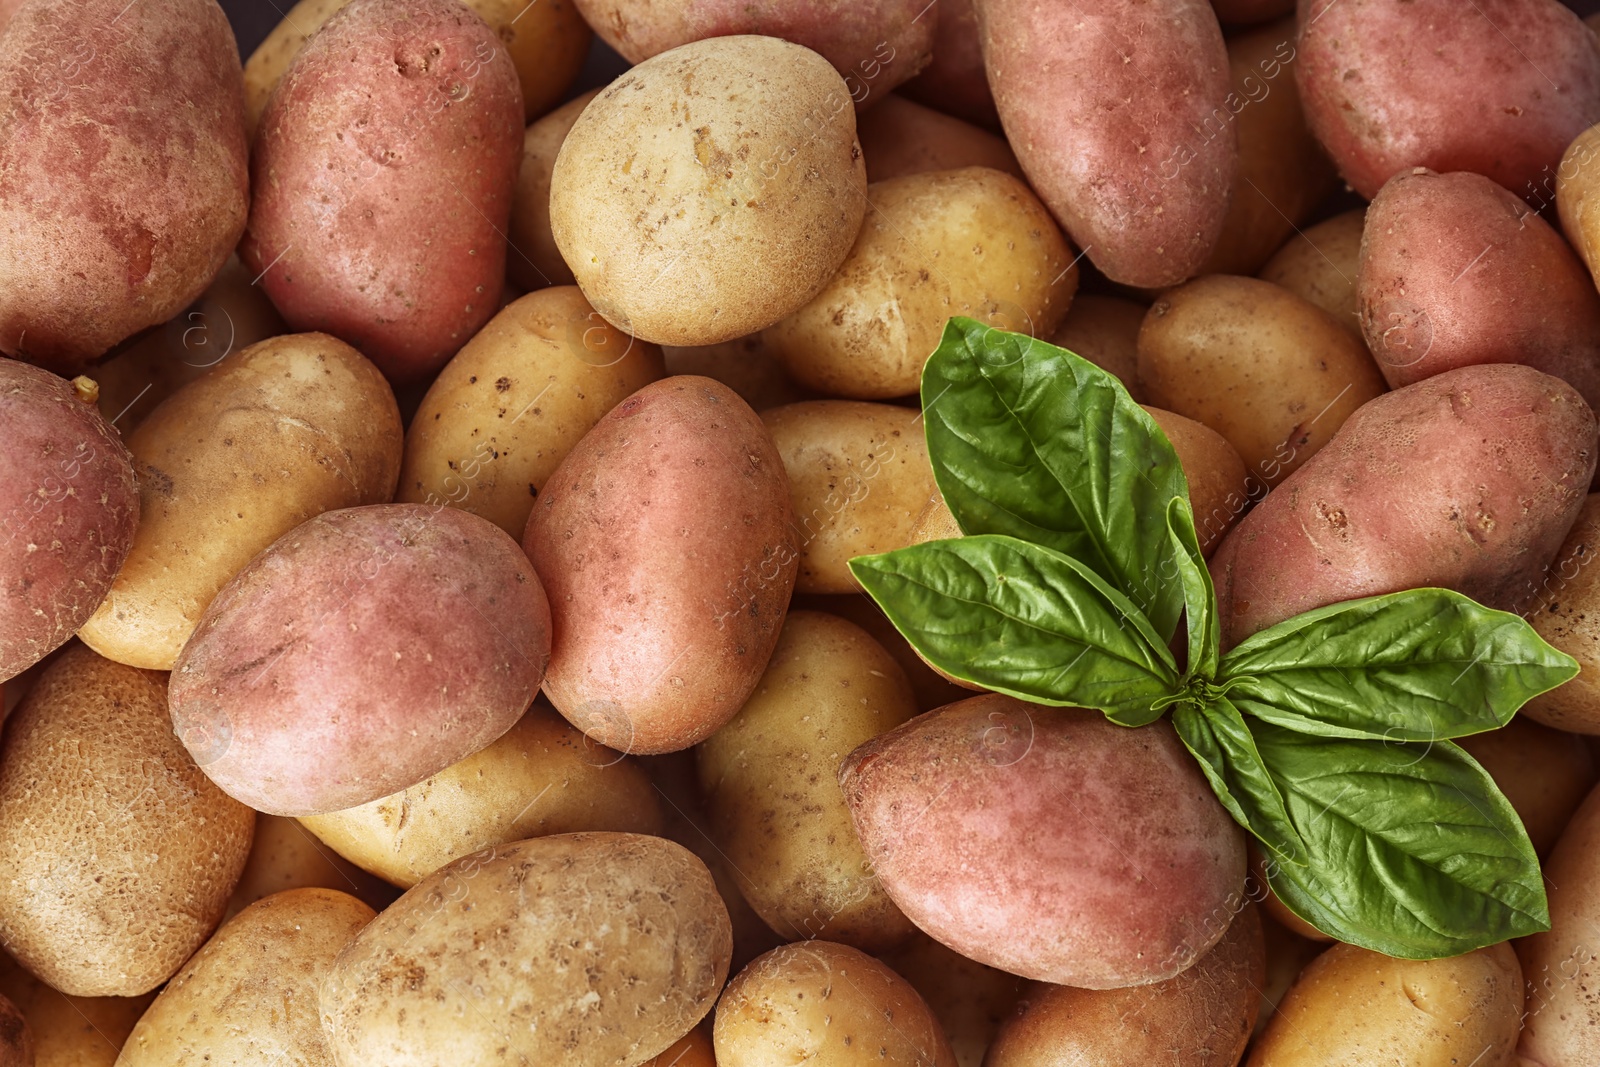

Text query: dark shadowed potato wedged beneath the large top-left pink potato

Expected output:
[94,256,288,435]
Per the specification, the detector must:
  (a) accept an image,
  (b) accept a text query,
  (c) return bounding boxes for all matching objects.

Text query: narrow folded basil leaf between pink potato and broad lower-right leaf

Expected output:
[1173,697,1306,864]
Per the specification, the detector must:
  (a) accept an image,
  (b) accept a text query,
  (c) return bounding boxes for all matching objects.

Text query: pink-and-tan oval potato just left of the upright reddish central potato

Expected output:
[168,504,550,816]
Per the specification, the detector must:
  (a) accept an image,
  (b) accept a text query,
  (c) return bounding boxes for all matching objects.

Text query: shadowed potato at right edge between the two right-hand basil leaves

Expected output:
[1456,715,1595,856]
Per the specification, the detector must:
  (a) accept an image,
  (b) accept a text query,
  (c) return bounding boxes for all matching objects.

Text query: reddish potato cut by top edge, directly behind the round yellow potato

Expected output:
[574,0,941,100]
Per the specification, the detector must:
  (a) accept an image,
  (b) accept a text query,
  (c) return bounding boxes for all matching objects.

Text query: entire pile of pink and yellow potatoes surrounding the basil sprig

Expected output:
[12,0,1600,1067]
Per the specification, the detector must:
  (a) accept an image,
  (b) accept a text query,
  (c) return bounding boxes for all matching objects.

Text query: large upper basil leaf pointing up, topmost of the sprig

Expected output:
[922,318,1189,641]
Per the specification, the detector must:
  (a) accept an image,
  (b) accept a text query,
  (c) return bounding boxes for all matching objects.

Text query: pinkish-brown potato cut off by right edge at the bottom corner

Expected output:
[1517,780,1600,1067]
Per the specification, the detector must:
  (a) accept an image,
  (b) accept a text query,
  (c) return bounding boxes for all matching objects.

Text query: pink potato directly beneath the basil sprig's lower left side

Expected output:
[838,694,1245,989]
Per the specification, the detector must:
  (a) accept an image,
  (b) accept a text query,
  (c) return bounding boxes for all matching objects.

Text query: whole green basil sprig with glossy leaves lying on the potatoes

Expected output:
[850,318,1578,960]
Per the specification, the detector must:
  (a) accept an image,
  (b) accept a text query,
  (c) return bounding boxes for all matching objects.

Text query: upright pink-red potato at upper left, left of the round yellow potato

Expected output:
[240,0,523,386]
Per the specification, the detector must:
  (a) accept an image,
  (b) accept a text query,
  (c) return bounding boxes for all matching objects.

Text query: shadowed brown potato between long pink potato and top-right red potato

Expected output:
[1198,21,1338,274]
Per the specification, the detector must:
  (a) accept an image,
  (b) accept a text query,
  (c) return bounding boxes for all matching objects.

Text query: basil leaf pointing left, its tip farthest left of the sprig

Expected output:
[850,534,1178,725]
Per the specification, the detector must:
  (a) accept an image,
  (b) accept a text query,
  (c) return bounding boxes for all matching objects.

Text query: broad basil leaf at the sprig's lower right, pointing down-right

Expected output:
[1250,721,1550,960]
